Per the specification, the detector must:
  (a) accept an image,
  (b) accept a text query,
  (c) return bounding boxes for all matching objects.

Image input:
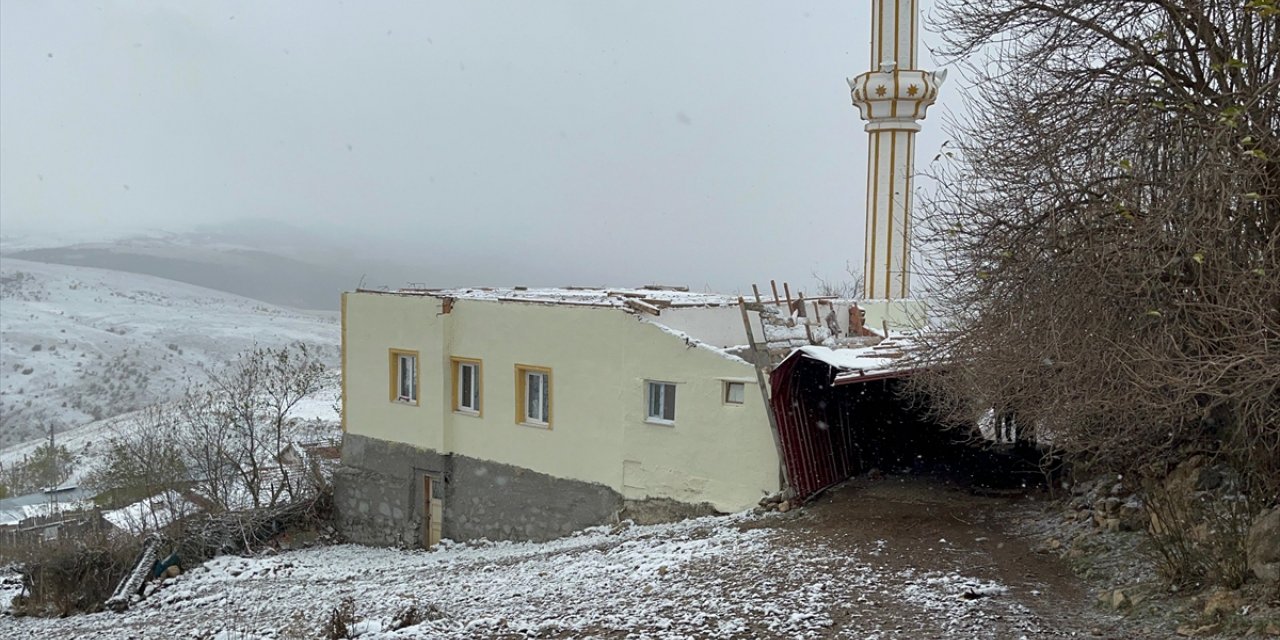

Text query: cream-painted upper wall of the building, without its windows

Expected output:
[346,293,778,511]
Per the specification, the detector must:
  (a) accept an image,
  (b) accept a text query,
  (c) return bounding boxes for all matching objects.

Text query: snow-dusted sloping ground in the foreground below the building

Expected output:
[0,515,1039,639]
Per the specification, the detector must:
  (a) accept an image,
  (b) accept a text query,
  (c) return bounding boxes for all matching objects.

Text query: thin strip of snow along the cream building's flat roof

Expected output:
[358,285,737,311]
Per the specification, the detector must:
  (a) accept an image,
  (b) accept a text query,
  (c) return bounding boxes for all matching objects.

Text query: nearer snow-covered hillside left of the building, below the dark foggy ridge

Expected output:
[0,259,339,447]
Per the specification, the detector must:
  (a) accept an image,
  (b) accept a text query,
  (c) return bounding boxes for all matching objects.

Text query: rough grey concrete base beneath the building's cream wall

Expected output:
[334,434,632,547]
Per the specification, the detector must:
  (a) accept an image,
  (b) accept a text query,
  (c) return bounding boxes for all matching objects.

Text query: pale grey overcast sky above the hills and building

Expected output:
[0,0,959,291]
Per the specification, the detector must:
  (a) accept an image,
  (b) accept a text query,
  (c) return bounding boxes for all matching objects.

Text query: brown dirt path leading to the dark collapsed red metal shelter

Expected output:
[757,476,1167,639]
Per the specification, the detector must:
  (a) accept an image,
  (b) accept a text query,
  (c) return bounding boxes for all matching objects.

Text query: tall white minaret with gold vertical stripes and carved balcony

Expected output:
[849,0,946,301]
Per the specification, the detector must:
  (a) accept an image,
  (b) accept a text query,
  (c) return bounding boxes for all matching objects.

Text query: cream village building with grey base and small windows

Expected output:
[335,288,781,545]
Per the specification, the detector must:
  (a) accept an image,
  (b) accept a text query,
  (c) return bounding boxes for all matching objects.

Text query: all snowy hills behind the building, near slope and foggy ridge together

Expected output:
[0,220,555,448]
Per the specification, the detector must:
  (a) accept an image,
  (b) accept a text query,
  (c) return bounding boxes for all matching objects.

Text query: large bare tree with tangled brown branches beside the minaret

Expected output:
[920,0,1280,497]
